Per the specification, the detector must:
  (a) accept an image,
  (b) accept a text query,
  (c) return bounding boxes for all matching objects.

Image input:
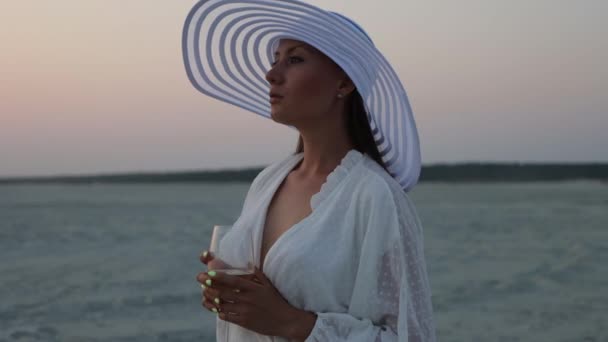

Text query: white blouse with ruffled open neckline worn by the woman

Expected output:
[217,150,435,342]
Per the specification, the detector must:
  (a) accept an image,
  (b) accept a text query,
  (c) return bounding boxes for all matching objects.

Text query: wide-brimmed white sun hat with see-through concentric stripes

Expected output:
[182,0,421,191]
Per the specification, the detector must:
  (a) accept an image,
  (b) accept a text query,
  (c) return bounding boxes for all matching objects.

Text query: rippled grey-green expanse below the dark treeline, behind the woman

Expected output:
[0,182,608,341]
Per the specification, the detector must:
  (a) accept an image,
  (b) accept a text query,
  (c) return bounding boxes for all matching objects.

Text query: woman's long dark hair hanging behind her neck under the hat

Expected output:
[295,89,388,172]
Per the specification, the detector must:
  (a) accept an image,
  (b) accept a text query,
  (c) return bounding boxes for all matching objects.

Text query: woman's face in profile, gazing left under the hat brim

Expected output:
[266,39,345,127]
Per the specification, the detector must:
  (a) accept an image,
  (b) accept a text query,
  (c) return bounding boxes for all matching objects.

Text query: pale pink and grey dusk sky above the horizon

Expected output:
[0,0,608,177]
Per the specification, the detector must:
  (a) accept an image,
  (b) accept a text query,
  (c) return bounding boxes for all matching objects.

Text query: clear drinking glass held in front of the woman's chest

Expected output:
[207,225,255,276]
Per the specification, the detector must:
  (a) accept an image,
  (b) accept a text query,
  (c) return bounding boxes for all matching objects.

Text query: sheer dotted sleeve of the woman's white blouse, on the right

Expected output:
[305,180,436,342]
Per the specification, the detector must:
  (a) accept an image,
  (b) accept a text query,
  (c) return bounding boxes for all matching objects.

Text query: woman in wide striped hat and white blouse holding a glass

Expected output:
[183,0,435,342]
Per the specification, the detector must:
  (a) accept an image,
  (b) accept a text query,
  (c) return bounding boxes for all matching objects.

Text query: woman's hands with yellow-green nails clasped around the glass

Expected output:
[196,253,316,340]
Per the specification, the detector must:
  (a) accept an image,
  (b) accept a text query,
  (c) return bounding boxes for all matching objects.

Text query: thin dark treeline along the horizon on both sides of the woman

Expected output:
[0,163,608,184]
